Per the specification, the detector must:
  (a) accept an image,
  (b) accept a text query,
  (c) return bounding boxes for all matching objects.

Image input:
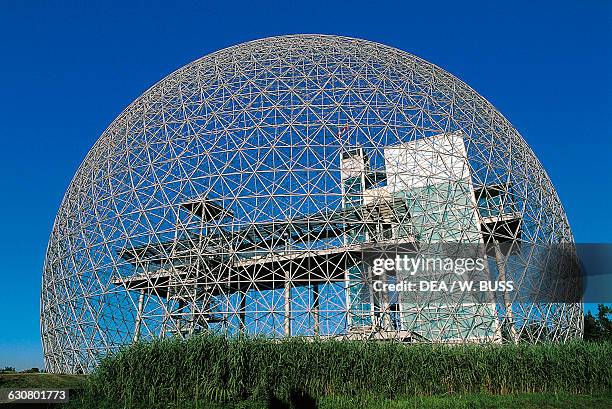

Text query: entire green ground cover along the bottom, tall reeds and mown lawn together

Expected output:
[5,336,612,409]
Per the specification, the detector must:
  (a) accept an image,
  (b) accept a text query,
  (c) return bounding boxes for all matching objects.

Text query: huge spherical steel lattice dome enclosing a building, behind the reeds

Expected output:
[41,35,582,372]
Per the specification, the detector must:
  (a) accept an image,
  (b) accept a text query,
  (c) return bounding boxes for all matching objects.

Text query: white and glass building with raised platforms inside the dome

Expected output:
[113,134,520,342]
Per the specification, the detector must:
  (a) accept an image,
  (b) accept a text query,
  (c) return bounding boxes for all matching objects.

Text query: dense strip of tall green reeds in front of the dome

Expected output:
[89,336,612,407]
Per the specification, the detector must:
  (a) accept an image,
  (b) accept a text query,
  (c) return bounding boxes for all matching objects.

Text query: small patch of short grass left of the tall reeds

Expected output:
[0,373,87,389]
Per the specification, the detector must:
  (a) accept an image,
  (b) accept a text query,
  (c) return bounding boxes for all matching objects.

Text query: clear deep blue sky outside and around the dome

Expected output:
[0,0,612,369]
